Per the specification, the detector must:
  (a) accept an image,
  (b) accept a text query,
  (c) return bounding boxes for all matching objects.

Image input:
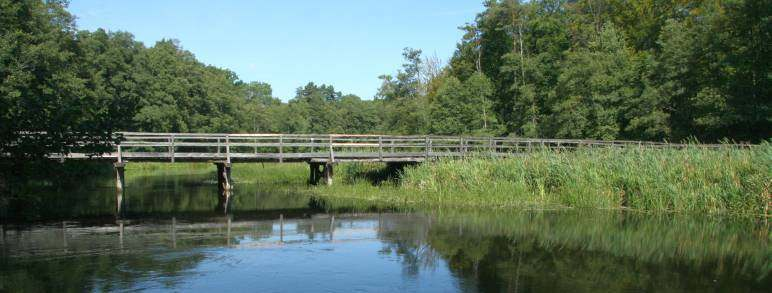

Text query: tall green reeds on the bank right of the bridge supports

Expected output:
[313,144,772,215]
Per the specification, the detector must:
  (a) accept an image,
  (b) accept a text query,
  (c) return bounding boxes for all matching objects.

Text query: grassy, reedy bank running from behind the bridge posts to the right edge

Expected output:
[6,143,772,216]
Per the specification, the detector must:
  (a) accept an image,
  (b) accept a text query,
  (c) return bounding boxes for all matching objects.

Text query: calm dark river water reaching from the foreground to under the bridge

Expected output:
[0,168,772,292]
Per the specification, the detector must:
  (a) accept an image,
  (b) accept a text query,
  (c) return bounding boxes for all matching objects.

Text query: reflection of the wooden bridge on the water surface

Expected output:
[0,211,404,257]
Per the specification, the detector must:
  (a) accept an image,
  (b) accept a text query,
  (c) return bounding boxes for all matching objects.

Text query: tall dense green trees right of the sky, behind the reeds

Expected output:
[447,0,772,141]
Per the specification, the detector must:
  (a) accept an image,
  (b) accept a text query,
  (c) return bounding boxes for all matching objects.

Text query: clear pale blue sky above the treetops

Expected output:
[69,0,483,100]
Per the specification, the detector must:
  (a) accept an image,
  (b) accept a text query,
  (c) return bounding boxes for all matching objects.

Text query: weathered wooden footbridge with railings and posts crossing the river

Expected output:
[54,132,747,190]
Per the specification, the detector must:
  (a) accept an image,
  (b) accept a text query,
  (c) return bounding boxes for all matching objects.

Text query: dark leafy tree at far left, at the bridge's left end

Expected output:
[0,0,121,160]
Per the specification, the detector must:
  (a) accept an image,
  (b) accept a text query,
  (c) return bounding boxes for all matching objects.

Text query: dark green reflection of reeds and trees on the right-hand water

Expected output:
[384,212,770,292]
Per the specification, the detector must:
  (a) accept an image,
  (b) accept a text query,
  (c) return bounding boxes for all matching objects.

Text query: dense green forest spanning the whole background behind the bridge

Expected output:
[0,0,772,160]
